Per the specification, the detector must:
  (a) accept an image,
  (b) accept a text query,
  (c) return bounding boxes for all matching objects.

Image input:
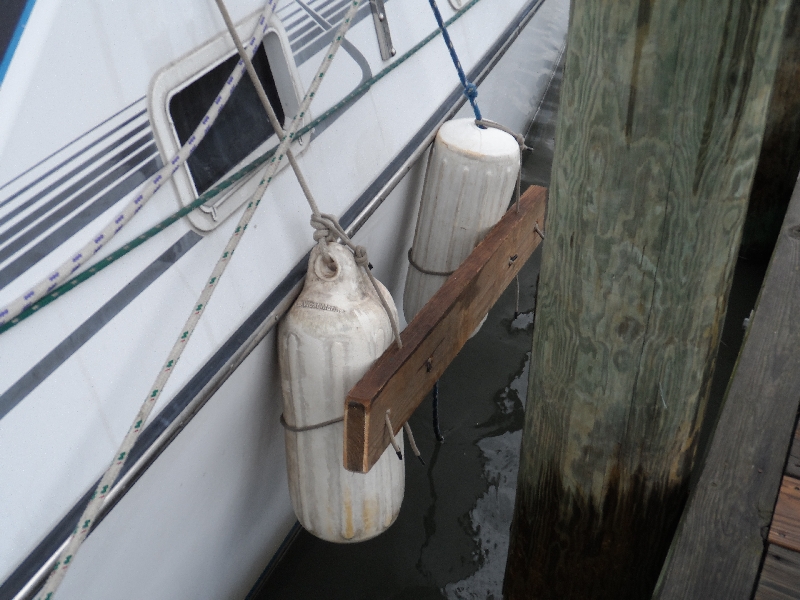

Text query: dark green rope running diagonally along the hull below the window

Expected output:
[0,0,488,333]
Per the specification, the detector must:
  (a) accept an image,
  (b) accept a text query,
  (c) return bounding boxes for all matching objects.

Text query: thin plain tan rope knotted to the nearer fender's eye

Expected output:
[216,0,403,348]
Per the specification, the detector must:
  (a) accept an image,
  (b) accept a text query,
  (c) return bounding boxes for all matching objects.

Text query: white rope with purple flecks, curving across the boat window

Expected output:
[0,0,277,325]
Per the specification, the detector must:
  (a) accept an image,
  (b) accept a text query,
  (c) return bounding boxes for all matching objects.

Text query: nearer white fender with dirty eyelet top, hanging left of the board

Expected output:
[278,242,405,543]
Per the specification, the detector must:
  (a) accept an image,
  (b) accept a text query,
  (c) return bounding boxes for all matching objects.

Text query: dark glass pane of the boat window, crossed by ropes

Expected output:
[169,45,285,195]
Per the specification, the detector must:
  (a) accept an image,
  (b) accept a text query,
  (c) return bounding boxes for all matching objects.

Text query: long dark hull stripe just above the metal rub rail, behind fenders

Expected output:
[0,0,545,600]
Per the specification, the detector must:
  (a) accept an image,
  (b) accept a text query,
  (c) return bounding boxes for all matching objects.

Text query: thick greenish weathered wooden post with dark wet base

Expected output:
[504,0,787,600]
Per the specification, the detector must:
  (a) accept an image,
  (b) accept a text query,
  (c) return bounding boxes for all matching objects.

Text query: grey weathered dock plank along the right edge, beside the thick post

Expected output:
[654,172,800,600]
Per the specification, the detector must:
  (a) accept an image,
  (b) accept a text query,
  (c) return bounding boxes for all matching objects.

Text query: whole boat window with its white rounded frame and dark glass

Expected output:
[148,11,311,231]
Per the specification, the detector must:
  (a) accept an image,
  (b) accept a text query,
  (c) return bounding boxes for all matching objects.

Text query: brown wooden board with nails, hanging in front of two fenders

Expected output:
[344,186,547,473]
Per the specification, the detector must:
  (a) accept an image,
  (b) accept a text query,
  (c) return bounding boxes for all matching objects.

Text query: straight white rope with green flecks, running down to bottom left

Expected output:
[39,0,360,600]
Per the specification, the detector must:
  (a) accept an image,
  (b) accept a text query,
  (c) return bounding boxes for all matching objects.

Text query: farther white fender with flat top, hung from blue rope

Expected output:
[403,119,522,331]
